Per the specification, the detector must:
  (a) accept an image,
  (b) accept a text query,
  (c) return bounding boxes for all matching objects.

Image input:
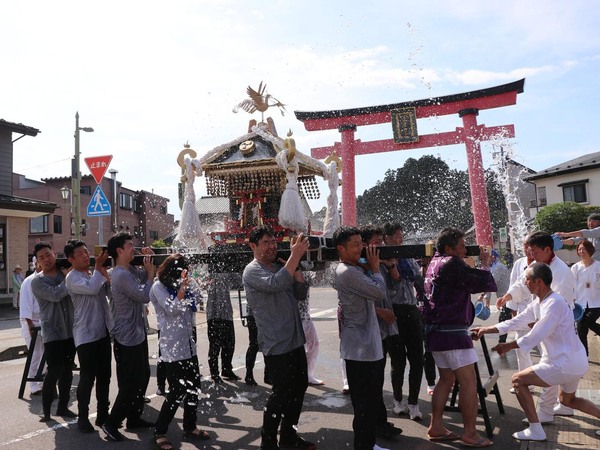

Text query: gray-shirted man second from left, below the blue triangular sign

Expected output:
[64,240,112,433]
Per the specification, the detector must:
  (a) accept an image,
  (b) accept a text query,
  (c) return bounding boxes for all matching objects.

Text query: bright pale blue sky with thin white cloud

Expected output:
[0,0,600,223]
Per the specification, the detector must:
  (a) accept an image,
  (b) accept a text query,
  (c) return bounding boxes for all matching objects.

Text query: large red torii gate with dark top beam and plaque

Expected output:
[294,79,525,245]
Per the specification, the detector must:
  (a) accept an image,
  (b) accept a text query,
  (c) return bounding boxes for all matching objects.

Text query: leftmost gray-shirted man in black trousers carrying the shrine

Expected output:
[31,242,77,422]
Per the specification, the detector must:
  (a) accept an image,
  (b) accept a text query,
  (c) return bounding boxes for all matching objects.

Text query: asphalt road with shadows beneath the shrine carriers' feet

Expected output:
[0,288,600,450]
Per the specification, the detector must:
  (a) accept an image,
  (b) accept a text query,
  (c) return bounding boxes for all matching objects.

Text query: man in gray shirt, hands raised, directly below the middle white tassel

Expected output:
[242,226,317,450]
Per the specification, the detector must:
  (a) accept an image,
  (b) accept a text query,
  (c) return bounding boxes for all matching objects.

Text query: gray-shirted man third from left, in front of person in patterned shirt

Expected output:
[102,232,156,441]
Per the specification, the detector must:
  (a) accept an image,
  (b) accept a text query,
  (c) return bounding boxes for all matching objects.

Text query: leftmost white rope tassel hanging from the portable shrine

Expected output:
[175,158,208,249]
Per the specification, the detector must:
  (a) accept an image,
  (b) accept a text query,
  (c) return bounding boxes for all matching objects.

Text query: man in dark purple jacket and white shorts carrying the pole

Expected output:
[423,228,496,447]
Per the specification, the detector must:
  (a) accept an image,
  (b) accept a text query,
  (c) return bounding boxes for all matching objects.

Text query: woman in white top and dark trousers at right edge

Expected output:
[571,241,600,355]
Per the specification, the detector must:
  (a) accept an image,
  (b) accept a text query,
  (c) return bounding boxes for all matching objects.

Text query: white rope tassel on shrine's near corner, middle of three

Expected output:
[275,149,308,232]
